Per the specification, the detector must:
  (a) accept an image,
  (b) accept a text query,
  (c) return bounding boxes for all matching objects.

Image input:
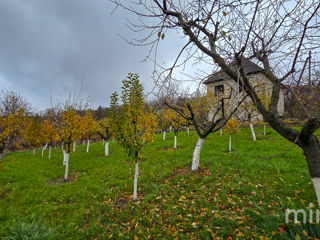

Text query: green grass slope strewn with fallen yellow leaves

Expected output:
[0,128,319,239]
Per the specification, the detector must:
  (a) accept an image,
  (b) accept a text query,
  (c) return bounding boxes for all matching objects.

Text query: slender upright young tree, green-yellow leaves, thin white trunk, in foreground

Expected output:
[111,73,156,200]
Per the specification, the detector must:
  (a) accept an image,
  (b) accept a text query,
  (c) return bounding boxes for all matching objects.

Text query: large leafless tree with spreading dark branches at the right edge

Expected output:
[111,0,320,205]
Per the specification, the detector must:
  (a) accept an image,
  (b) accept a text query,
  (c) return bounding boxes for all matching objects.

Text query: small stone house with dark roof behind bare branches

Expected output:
[204,58,284,121]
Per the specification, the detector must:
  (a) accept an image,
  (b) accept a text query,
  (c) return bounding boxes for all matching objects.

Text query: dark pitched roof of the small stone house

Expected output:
[203,57,264,85]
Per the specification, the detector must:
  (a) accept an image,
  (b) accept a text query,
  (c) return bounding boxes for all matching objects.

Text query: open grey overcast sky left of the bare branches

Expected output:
[0,0,184,110]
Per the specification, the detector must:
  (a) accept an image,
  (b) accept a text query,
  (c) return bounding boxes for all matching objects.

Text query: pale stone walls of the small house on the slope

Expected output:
[207,73,284,122]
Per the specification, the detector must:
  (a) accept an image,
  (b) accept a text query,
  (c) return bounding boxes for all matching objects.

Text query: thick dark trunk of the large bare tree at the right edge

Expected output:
[303,140,320,207]
